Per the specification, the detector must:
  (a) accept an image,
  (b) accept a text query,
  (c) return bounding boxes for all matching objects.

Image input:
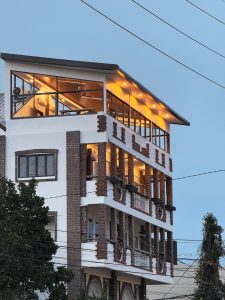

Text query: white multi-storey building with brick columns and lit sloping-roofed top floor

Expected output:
[0,53,189,300]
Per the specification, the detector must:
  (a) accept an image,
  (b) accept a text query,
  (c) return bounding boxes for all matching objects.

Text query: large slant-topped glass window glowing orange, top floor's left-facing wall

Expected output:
[11,71,103,118]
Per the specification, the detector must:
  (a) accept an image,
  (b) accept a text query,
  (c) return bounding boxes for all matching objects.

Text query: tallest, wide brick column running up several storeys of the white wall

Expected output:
[66,131,83,300]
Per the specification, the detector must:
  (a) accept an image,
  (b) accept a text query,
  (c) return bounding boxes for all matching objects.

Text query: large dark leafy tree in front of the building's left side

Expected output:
[0,178,73,300]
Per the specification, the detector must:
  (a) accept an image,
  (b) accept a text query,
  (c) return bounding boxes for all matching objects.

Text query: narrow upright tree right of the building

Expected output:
[194,213,225,300]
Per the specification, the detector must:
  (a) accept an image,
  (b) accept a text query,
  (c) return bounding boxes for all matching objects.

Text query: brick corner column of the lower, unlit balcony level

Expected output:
[97,204,107,259]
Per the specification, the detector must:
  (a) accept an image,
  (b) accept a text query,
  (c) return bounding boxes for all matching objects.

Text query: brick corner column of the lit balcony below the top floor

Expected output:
[96,143,107,196]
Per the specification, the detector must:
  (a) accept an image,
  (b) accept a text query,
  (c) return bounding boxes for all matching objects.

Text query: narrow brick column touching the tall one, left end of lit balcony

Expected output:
[80,144,87,197]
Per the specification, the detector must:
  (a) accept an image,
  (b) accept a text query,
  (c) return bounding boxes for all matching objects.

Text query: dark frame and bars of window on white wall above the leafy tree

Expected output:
[15,149,58,182]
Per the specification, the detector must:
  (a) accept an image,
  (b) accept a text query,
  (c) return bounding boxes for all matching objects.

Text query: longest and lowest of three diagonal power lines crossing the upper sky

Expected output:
[80,0,225,89]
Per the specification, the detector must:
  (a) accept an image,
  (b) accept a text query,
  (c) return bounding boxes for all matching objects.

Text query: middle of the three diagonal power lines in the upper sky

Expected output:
[130,0,225,58]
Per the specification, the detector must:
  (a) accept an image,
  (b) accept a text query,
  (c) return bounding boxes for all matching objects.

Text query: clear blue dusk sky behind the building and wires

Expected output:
[0,0,225,258]
